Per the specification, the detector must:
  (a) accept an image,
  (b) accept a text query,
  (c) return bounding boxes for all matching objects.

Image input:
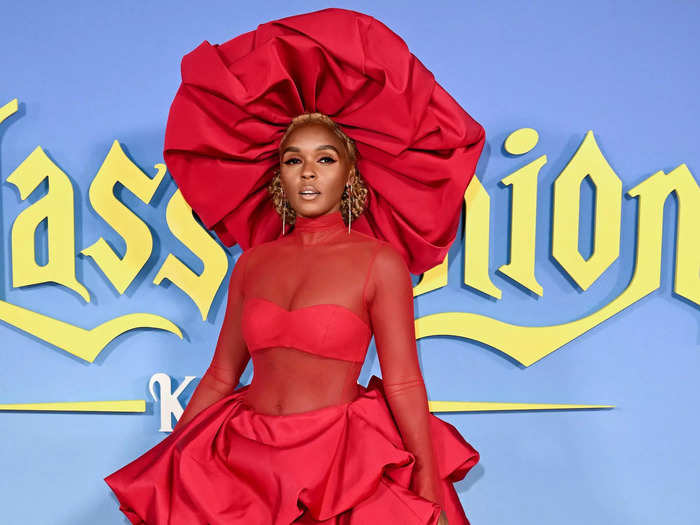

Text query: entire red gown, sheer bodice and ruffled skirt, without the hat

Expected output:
[105,212,479,525]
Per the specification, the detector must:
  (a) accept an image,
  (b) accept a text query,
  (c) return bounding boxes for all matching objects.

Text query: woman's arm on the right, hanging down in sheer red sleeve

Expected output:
[366,244,443,507]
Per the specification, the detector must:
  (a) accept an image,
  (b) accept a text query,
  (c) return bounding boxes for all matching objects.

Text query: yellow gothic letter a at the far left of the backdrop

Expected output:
[7,146,90,302]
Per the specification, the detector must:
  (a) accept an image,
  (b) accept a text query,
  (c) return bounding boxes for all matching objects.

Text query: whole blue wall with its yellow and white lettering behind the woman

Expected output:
[0,0,700,525]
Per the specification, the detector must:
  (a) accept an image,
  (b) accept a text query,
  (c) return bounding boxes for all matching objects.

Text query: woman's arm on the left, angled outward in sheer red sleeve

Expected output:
[173,248,250,432]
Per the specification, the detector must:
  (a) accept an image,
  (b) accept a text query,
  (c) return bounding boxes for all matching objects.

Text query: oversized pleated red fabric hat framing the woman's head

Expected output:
[164,9,484,274]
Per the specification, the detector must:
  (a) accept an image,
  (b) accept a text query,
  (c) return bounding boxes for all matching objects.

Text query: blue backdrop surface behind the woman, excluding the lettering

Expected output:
[0,0,700,525]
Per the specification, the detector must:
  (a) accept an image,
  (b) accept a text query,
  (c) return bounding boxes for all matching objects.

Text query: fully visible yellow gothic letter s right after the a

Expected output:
[81,140,166,294]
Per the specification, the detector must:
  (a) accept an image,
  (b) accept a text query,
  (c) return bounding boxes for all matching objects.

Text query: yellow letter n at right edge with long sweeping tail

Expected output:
[416,164,700,366]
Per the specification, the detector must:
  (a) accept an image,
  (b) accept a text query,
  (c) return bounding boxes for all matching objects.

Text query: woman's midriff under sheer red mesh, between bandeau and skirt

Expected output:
[245,347,362,415]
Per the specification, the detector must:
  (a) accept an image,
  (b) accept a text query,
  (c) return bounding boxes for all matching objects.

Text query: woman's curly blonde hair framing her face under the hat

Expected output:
[267,113,367,225]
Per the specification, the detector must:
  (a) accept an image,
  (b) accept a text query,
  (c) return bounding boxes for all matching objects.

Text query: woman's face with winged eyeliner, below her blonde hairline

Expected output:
[280,123,351,217]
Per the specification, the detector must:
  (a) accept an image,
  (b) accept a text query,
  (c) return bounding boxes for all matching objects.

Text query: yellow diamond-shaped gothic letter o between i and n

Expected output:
[552,131,622,290]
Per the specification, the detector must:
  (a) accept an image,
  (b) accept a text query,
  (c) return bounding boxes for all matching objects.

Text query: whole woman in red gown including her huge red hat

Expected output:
[106,9,483,525]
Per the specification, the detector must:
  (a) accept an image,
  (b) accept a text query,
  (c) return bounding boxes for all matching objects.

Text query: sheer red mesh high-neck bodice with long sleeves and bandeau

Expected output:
[176,212,442,504]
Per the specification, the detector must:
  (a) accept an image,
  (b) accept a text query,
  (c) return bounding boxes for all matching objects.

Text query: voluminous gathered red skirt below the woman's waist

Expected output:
[105,376,479,525]
